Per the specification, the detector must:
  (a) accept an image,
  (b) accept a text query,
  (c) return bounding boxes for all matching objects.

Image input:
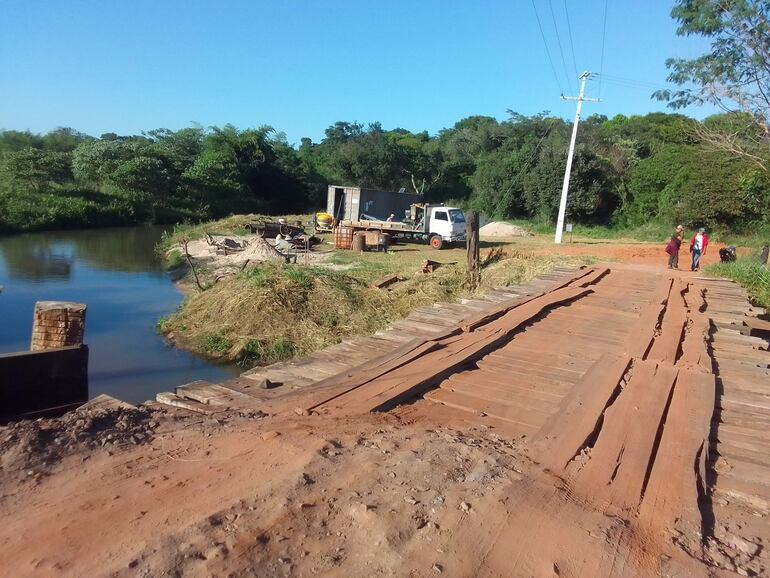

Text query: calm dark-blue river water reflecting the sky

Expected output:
[0,226,238,403]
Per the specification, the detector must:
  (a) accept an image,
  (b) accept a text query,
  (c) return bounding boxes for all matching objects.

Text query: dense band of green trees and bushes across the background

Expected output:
[0,113,770,231]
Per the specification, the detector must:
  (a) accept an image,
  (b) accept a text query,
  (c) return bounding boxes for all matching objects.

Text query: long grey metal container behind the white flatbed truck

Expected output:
[326,185,423,221]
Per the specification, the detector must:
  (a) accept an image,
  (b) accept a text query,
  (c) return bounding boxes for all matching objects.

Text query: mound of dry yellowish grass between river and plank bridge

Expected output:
[159,250,585,366]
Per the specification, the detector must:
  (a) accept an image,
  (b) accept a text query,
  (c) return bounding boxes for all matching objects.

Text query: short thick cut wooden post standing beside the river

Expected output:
[30,301,86,351]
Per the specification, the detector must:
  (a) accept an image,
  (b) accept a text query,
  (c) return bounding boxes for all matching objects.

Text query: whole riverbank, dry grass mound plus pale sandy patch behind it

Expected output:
[158,215,592,367]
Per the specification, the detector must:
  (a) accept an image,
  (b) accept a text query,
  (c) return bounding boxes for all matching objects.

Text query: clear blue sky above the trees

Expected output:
[0,0,712,143]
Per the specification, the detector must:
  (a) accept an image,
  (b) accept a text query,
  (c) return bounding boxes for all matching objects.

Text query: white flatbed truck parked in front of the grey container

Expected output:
[339,203,465,249]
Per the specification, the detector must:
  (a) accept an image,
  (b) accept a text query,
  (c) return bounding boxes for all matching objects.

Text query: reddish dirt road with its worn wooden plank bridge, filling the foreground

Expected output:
[0,264,770,576]
